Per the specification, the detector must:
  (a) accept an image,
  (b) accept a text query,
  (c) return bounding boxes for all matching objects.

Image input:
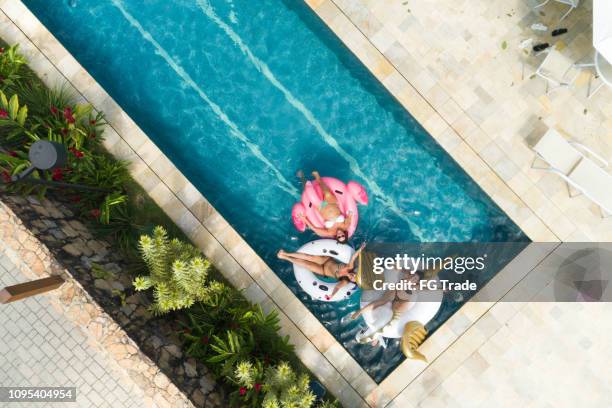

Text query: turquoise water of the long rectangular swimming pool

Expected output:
[24,0,526,382]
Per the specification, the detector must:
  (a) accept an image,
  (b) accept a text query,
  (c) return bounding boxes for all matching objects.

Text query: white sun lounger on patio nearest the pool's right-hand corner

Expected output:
[531,129,612,217]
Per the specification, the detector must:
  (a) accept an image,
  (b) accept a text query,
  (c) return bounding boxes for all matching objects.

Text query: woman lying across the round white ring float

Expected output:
[277,243,365,298]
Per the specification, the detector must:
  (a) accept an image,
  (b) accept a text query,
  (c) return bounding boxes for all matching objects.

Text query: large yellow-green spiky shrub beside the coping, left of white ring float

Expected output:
[134,226,210,314]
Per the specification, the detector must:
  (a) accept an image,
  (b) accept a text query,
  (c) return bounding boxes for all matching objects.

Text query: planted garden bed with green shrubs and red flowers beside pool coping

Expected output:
[0,39,340,407]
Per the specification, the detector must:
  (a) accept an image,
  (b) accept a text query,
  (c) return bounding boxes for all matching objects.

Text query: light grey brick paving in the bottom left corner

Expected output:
[0,253,146,408]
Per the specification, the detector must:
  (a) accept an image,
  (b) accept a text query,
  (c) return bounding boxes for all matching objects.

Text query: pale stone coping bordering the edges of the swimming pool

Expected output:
[0,0,558,407]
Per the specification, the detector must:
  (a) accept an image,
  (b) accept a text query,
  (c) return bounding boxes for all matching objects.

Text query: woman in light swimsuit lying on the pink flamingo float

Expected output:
[300,171,353,244]
